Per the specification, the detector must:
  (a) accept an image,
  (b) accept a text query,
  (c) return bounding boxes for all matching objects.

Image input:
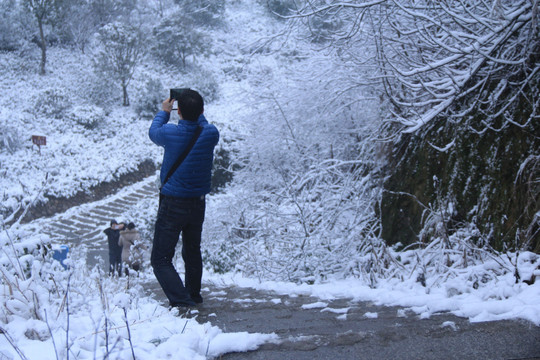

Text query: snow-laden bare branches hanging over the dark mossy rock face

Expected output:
[377,0,540,132]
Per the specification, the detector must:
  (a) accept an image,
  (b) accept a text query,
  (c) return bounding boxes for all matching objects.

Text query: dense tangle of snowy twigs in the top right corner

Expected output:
[380,1,536,133]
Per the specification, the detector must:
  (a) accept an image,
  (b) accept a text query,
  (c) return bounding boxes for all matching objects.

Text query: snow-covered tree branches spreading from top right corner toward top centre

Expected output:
[288,0,539,132]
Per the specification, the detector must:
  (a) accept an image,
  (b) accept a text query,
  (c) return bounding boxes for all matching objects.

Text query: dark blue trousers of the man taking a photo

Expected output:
[150,196,205,306]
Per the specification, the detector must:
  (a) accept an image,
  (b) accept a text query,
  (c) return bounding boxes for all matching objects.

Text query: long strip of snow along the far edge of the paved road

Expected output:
[207,264,540,326]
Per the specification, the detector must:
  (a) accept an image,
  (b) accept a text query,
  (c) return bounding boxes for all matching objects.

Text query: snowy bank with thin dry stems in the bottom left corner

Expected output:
[0,230,278,360]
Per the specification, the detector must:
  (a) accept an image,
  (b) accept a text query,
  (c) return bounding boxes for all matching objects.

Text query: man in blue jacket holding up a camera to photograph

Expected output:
[149,89,219,311]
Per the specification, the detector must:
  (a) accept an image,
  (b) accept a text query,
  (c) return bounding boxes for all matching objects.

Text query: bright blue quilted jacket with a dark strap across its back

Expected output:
[148,111,219,197]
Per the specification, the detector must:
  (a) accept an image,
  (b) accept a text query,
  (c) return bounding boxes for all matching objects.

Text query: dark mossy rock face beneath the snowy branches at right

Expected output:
[380,96,540,252]
